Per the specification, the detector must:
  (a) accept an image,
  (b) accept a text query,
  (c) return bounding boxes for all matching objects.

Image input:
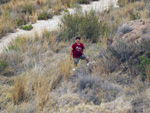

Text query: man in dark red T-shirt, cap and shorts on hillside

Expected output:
[70,37,89,70]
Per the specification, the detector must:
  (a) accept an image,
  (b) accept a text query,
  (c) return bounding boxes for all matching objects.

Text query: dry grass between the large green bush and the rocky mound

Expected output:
[100,1,146,38]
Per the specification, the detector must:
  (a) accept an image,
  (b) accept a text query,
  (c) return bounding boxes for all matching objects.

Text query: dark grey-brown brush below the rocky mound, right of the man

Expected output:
[95,41,149,76]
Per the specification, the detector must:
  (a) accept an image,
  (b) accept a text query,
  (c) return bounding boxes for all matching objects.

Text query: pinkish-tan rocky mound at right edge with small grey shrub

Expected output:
[113,19,150,43]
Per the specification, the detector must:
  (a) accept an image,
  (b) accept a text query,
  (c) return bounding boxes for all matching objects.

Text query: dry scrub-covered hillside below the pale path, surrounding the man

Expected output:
[0,0,150,113]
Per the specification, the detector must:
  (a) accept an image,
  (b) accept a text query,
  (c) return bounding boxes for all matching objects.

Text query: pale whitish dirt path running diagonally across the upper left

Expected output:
[0,0,117,52]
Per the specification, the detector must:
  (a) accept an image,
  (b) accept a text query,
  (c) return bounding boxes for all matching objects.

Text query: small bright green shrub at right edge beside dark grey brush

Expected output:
[139,56,150,76]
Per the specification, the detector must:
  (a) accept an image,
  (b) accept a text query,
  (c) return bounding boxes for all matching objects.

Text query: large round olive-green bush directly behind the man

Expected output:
[60,11,102,42]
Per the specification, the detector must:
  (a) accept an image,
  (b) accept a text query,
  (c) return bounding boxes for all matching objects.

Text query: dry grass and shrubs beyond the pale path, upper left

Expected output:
[0,0,101,37]
